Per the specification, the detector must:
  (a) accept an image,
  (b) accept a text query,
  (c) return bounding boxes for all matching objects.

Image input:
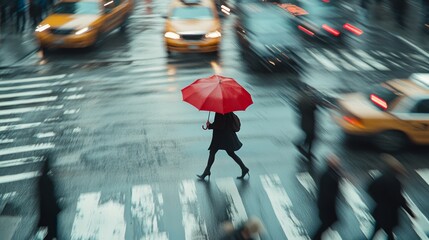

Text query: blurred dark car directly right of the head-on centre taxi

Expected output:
[235,2,300,71]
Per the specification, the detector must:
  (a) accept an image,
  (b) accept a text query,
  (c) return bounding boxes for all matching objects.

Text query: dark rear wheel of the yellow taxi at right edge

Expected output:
[373,131,408,152]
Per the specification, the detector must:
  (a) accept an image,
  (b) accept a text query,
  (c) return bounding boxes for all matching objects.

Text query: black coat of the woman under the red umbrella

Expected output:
[208,113,243,151]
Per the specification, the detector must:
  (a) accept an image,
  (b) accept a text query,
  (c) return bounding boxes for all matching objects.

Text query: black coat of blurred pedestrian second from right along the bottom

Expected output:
[317,167,341,225]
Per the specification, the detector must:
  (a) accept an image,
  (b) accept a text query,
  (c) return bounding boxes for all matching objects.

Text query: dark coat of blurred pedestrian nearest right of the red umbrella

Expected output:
[298,94,317,134]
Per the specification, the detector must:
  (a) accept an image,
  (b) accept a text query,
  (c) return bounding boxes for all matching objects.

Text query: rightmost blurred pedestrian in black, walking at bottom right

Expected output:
[368,154,415,240]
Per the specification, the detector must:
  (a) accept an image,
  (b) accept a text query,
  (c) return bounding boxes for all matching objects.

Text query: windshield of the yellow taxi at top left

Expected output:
[54,2,100,14]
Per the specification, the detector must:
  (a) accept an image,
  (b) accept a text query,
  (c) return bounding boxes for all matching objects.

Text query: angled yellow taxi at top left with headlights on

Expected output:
[35,0,133,49]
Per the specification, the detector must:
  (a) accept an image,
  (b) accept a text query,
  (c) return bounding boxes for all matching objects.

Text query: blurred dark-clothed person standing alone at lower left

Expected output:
[38,156,60,240]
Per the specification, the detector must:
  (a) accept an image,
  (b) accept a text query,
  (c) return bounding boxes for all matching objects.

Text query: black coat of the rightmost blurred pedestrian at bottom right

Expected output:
[368,172,413,229]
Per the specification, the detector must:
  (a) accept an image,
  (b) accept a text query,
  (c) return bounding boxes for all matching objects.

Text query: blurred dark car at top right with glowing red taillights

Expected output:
[278,0,363,43]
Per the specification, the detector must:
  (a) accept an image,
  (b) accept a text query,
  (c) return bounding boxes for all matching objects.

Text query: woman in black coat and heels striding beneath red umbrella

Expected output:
[197,113,249,180]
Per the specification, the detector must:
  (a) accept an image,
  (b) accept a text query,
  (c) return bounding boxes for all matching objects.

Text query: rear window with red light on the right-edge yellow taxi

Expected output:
[368,84,400,110]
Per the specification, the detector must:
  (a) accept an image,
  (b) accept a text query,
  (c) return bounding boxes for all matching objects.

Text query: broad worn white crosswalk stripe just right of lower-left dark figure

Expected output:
[71,192,126,240]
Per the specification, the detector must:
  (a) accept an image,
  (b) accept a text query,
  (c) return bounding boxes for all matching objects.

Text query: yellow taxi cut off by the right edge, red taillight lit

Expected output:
[334,73,429,151]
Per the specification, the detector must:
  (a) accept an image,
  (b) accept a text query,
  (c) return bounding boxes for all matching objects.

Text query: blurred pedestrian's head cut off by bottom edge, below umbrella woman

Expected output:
[222,218,264,240]
